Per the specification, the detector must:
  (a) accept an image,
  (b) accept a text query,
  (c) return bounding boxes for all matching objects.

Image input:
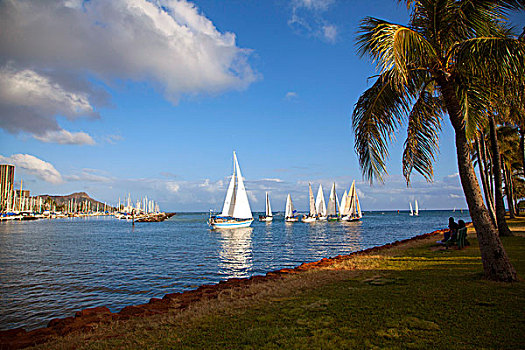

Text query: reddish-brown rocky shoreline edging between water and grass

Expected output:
[0,230,445,349]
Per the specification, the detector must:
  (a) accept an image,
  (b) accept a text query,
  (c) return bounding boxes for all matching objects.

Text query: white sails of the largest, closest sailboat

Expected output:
[221,152,253,219]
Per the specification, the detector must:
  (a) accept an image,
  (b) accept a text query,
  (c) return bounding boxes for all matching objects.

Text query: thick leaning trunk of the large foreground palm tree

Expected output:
[437,75,518,282]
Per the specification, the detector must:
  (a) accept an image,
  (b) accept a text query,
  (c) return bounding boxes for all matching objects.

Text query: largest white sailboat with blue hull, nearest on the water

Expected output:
[208,152,253,228]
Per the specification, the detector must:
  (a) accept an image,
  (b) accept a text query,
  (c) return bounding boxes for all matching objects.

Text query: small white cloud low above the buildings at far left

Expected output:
[0,154,63,184]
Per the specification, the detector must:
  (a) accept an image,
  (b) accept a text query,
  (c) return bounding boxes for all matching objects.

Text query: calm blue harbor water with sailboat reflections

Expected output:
[0,211,470,330]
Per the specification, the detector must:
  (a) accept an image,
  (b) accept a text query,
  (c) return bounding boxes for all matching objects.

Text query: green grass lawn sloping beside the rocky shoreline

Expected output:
[37,219,525,349]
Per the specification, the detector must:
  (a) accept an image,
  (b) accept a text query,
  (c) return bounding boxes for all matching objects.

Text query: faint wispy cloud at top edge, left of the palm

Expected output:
[288,0,338,43]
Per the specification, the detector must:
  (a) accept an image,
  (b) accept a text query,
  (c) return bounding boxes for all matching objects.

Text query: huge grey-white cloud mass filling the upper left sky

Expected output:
[0,0,258,142]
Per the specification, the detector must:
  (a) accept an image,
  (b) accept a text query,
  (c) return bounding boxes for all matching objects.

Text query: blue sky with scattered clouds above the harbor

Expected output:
[0,0,523,211]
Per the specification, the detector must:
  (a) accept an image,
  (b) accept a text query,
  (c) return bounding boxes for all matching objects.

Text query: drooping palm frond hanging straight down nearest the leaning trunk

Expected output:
[403,87,444,184]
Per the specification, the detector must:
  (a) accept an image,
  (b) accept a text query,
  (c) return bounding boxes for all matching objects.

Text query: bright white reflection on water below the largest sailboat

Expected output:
[215,227,253,278]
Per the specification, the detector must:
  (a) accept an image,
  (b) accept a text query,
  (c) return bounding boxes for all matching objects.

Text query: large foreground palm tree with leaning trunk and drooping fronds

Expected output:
[352,0,525,281]
